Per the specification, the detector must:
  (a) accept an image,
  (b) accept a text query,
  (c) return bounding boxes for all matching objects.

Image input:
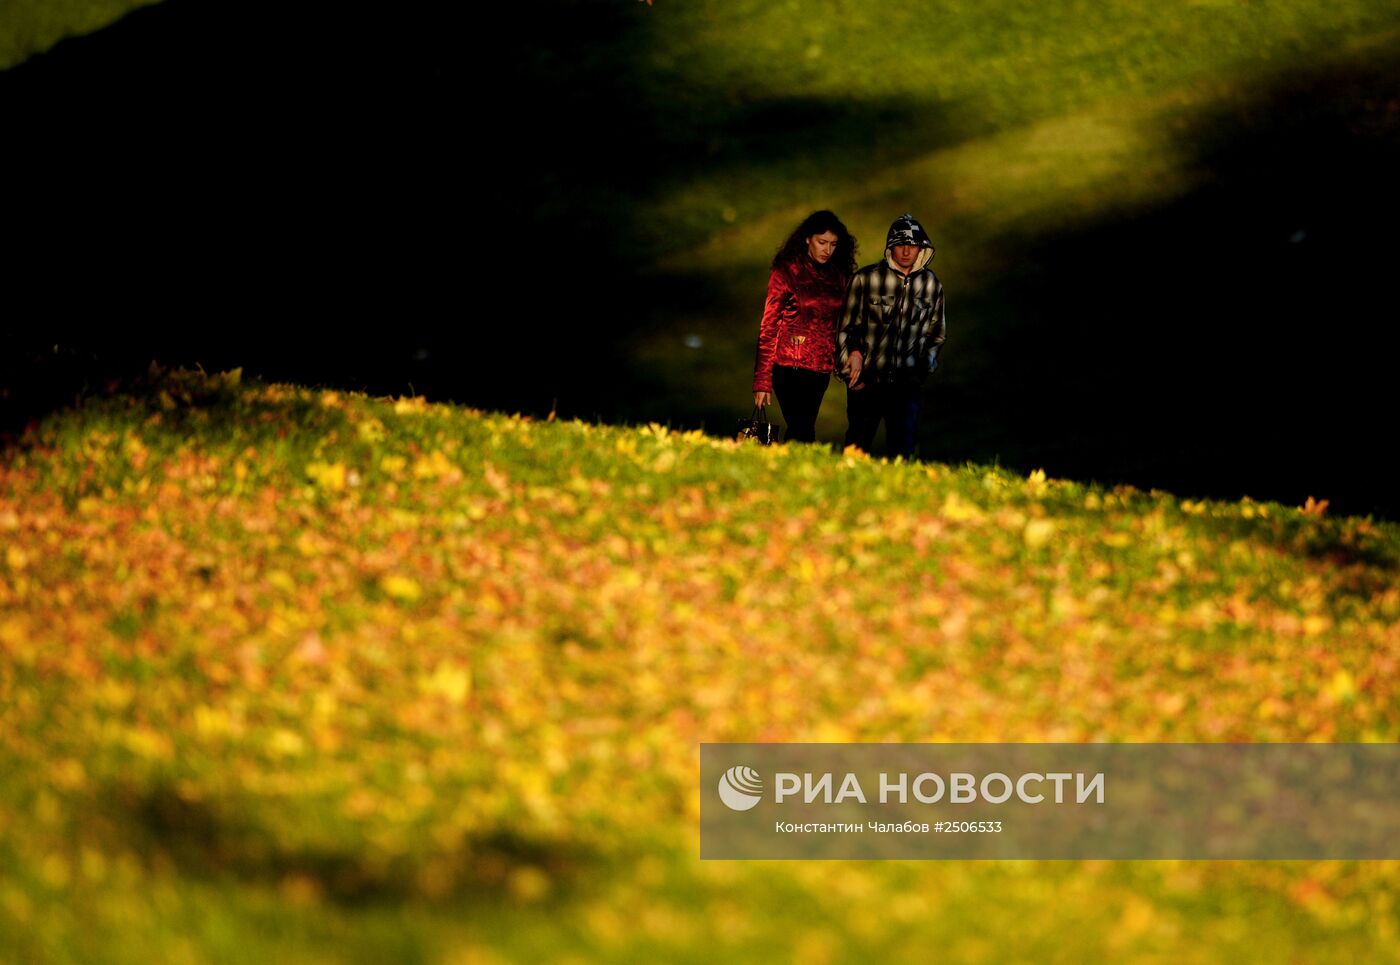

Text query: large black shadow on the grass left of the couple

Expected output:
[0,0,977,426]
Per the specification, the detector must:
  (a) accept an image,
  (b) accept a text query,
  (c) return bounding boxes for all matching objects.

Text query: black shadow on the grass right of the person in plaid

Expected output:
[923,49,1400,518]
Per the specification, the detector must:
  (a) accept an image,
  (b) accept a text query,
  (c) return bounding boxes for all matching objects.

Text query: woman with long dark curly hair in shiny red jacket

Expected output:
[753,211,855,443]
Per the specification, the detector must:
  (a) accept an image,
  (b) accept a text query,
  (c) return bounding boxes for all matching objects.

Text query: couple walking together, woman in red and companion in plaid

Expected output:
[753,211,946,458]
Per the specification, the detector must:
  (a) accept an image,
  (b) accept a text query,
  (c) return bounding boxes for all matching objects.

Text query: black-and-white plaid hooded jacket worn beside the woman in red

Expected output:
[836,214,948,382]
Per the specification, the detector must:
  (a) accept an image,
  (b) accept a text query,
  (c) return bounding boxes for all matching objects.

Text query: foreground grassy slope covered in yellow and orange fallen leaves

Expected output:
[0,373,1400,962]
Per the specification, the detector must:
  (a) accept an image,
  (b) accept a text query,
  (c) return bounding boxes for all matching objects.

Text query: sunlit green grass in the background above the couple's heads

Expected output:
[630,0,1400,261]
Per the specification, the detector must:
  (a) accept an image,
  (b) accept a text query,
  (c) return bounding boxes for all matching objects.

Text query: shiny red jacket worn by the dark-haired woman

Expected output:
[753,252,850,392]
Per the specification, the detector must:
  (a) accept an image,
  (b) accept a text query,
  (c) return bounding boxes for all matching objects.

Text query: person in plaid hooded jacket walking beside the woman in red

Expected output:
[836,214,946,458]
